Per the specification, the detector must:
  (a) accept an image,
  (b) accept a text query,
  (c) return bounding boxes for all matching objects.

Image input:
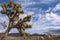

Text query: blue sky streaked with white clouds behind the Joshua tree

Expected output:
[0,0,60,34]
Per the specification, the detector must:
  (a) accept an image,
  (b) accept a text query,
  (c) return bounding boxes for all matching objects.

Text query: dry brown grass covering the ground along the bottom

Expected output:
[0,35,60,40]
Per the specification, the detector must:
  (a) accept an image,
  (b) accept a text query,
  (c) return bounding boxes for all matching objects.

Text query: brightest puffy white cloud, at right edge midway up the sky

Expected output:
[46,12,60,25]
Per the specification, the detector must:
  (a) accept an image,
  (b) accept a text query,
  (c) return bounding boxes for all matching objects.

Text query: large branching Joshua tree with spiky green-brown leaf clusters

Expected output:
[1,0,32,36]
